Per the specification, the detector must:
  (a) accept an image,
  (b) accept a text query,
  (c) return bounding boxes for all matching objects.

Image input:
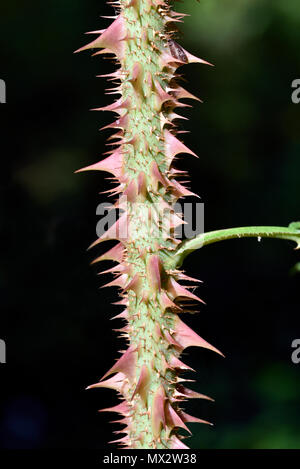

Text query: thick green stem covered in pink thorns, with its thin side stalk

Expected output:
[76,0,299,449]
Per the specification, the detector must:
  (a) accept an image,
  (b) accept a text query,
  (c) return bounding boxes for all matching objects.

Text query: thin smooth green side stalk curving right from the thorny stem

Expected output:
[170,222,300,268]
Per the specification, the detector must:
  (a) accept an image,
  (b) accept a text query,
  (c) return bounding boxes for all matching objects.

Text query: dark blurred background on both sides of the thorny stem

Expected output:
[0,0,300,449]
